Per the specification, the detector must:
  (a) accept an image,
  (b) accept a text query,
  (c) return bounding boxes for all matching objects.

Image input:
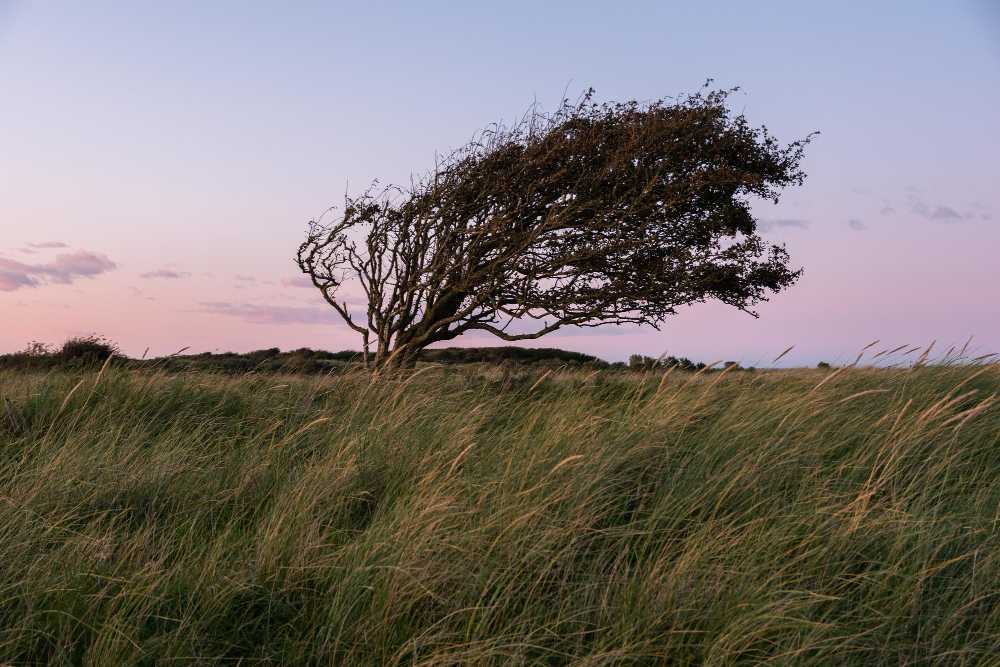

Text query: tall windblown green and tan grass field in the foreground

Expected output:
[0,365,1000,665]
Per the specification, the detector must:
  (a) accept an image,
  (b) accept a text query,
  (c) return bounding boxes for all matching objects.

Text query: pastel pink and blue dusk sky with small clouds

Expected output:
[0,0,1000,365]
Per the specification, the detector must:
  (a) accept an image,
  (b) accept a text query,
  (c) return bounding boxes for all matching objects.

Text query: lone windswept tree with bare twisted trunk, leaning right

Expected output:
[297,89,811,366]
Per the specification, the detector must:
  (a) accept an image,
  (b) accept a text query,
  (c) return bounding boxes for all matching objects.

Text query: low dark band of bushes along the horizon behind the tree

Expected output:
[0,336,753,375]
